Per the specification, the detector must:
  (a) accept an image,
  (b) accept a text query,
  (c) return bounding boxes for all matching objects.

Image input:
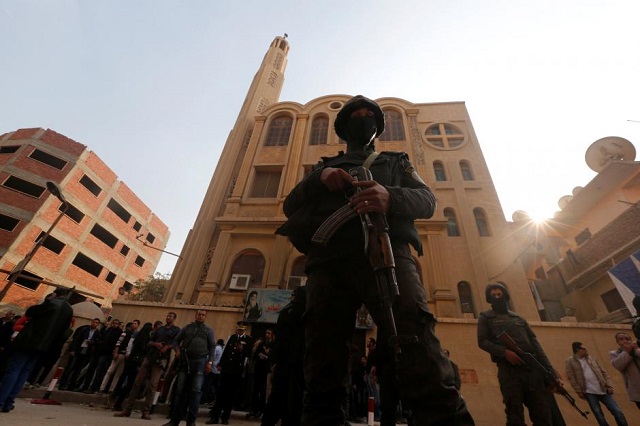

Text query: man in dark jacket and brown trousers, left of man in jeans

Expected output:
[113,312,180,420]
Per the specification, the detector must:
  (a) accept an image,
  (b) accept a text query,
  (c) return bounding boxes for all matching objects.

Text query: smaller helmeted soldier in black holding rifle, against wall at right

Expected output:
[478,283,555,426]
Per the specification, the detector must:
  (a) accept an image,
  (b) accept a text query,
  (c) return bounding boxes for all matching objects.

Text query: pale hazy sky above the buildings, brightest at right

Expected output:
[0,0,640,273]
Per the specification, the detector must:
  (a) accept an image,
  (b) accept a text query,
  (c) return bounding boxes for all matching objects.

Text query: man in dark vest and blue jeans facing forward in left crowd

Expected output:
[163,309,216,426]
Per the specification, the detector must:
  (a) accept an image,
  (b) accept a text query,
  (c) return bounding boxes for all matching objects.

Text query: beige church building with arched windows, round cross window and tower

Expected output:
[164,37,539,320]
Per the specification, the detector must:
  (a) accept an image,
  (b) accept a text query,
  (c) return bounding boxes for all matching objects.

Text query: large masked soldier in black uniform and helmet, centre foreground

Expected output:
[277,96,474,426]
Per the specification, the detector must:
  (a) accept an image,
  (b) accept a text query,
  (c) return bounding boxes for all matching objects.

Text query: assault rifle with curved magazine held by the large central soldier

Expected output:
[311,166,410,361]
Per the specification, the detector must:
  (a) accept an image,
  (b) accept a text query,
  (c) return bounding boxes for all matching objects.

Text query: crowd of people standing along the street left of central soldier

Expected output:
[0,288,305,426]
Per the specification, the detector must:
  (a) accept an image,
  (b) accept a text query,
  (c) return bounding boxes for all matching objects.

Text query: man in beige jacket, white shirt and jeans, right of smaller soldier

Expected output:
[565,342,627,426]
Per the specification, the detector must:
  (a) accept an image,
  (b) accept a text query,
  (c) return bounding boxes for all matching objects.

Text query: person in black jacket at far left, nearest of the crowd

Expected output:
[0,288,73,413]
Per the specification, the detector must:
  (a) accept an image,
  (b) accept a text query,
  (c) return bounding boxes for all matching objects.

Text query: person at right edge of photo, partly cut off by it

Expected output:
[609,332,640,408]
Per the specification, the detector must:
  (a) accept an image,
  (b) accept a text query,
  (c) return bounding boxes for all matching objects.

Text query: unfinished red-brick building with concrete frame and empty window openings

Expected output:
[0,128,169,308]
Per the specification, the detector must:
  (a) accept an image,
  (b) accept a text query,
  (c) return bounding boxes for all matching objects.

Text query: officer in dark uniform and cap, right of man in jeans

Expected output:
[206,321,253,425]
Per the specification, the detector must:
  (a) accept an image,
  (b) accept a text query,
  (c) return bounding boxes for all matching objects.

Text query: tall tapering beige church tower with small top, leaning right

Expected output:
[164,35,289,303]
